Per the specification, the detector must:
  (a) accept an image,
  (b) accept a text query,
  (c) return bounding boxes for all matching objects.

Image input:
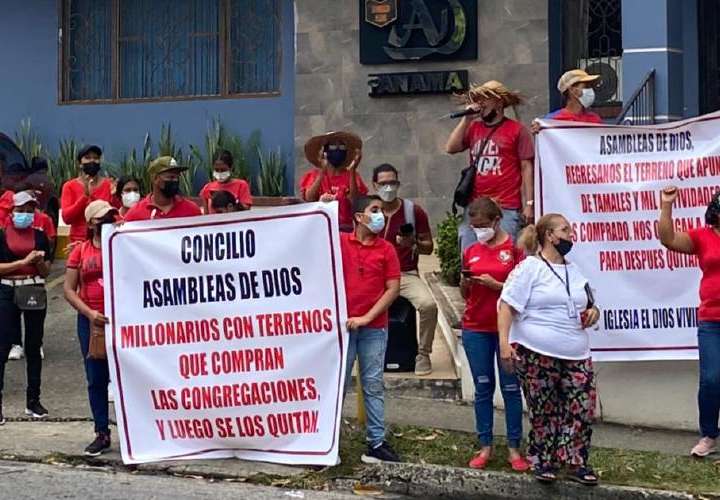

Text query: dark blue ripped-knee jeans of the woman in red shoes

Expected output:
[462,330,522,448]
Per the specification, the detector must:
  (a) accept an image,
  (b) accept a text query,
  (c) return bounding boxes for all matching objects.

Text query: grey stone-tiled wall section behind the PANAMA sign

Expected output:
[295,0,548,224]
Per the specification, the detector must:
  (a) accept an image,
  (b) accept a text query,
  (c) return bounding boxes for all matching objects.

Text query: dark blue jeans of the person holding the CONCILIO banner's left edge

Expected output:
[77,314,110,432]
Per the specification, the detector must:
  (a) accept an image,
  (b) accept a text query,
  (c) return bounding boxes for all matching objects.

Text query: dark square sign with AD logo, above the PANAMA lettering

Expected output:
[360,0,478,64]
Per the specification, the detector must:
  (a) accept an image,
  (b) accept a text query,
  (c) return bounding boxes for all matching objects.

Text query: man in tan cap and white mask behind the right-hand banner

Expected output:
[531,69,602,130]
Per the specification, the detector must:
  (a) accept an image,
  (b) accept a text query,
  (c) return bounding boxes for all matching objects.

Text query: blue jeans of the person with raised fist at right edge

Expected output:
[698,322,720,439]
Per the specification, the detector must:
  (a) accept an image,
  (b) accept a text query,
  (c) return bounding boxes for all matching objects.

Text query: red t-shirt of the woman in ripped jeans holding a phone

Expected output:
[463,238,524,333]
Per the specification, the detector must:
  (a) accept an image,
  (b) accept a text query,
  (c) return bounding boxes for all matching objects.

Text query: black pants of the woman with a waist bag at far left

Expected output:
[0,285,47,402]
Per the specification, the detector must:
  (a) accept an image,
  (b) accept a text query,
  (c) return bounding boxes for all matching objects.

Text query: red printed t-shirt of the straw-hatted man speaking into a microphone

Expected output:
[464,118,535,210]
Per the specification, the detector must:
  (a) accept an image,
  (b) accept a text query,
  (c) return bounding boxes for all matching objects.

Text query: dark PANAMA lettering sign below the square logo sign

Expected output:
[368,70,469,97]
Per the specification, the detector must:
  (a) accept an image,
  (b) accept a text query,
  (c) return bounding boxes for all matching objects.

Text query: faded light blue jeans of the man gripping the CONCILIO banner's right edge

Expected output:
[345,328,387,448]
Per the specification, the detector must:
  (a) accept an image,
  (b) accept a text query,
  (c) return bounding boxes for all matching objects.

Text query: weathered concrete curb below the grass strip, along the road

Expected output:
[362,463,712,500]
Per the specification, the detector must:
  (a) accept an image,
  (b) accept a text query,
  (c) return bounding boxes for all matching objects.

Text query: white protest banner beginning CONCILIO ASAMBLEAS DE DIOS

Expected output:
[103,204,347,465]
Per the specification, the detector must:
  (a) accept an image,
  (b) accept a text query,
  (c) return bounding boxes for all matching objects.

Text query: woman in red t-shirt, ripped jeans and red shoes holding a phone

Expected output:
[460,196,530,472]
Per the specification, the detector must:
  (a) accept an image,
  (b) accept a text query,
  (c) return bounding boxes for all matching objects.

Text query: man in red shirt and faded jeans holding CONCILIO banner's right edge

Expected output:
[340,196,400,463]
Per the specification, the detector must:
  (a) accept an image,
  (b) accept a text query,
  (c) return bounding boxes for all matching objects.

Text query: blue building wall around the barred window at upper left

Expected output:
[0,0,295,186]
